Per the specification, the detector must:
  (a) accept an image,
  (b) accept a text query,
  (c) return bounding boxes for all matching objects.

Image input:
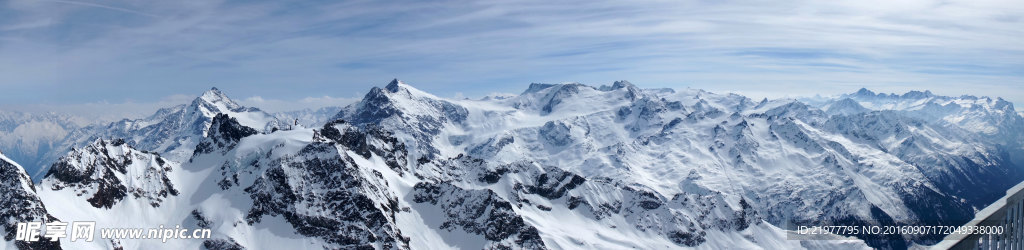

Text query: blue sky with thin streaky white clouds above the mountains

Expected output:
[0,0,1024,118]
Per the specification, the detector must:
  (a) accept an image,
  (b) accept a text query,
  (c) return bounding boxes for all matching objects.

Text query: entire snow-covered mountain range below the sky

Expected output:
[0,80,1024,249]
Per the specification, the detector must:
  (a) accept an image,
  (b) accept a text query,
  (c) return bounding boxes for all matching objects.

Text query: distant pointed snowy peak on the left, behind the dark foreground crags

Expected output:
[36,88,284,177]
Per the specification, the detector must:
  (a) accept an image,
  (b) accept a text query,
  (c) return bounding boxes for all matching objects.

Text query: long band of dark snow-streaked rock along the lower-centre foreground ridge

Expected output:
[414,156,762,247]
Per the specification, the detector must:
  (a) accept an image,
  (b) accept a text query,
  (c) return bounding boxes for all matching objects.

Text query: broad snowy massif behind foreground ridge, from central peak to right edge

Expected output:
[338,81,1021,247]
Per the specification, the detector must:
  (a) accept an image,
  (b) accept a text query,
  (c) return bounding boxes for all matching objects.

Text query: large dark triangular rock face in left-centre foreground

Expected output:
[245,142,409,249]
